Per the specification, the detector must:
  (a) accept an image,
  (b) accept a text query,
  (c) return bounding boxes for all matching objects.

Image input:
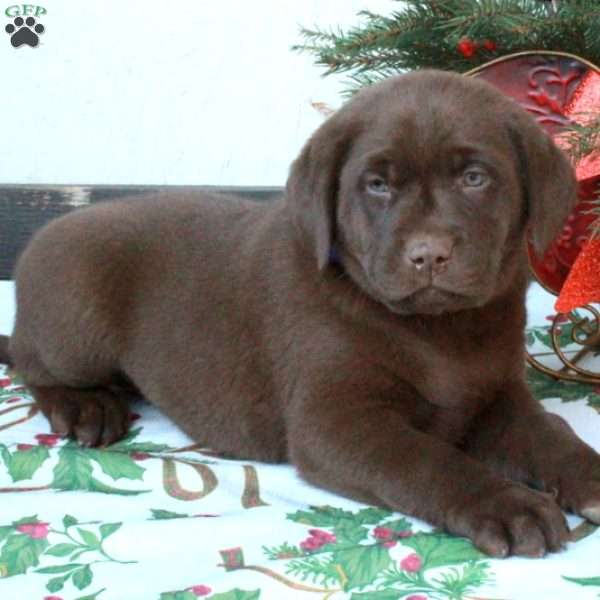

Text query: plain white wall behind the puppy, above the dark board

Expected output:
[0,0,398,185]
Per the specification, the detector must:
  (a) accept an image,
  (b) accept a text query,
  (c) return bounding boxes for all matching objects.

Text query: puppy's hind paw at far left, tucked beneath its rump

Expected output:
[30,386,129,446]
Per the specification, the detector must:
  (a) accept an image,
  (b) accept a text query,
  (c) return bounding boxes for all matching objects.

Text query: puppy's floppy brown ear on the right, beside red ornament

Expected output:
[509,109,577,256]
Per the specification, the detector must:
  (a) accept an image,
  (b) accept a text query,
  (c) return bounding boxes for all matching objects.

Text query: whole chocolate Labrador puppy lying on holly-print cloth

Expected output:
[5,71,600,557]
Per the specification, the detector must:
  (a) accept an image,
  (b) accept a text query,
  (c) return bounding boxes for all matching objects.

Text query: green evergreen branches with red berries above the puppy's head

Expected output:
[295,0,600,93]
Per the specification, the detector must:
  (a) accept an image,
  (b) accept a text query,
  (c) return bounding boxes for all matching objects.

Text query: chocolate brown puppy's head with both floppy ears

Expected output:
[287,71,576,314]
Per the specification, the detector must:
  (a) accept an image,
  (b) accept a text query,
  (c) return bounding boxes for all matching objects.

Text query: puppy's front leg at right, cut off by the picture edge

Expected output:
[466,382,600,523]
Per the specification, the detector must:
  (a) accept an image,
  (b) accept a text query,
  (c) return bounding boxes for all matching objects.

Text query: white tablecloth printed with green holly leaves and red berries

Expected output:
[0,314,600,600]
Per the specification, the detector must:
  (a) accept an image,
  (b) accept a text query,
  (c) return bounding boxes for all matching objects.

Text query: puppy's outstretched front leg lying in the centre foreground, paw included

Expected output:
[288,380,568,556]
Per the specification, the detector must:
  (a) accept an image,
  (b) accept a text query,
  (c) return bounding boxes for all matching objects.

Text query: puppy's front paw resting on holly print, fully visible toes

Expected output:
[446,484,569,558]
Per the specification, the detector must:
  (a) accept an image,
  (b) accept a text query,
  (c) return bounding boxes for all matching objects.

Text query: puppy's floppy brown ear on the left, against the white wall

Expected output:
[286,109,356,270]
